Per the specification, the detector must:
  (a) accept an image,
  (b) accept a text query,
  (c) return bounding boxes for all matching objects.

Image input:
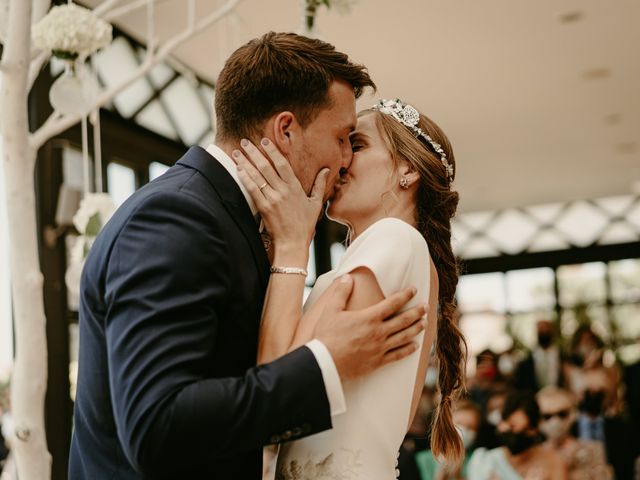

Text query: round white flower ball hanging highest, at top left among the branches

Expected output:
[32,3,113,59]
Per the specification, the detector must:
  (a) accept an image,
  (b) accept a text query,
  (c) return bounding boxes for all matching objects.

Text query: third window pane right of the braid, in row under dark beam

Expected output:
[558,262,607,307]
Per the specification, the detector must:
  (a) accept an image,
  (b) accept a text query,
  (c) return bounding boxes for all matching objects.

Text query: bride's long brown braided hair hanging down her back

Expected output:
[366,111,467,463]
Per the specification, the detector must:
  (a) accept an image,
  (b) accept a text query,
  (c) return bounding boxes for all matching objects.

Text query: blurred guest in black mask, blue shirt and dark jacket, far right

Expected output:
[576,367,639,480]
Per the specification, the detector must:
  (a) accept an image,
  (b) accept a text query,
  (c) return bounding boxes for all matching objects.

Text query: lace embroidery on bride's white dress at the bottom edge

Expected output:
[275,449,363,480]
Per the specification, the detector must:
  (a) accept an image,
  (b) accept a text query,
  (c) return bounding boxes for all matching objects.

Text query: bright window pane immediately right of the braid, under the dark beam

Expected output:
[457,273,506,313]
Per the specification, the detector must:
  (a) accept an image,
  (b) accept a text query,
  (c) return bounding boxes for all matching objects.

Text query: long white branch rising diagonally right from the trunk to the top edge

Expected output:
[29,0,244,150]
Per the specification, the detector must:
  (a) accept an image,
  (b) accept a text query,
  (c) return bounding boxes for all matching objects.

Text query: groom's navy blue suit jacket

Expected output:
[69,147,331,480]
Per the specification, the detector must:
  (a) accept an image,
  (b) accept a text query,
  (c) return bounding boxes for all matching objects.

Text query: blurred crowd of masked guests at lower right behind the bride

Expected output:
[399,319,640,480]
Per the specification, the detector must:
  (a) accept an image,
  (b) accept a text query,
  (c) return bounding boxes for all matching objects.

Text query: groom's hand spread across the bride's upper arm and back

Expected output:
[314,275,426,380]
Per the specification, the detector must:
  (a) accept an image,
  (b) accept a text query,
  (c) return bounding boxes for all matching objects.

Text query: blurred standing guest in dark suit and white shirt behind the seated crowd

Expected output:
[513,320,564,393]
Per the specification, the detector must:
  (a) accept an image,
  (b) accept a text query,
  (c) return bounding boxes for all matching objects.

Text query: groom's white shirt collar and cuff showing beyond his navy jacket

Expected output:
[207,144,347,416]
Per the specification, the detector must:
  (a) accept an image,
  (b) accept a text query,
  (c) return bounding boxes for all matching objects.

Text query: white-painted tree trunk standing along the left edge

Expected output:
[0,0,51,480]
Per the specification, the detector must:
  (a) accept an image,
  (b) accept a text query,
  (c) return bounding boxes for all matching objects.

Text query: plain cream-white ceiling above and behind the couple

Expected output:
[84,0,640,212]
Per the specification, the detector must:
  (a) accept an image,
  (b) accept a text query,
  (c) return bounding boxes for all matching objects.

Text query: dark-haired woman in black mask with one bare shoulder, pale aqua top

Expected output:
[467,391,568,480]
